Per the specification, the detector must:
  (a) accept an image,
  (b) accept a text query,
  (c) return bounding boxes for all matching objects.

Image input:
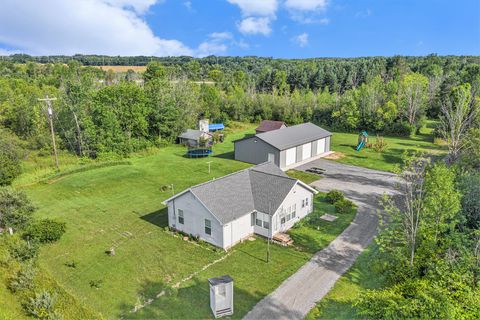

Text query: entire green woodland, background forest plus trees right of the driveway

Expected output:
[0,55,480,319]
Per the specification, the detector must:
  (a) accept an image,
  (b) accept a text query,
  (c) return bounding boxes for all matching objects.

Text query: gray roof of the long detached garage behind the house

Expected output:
[255,122,332,150]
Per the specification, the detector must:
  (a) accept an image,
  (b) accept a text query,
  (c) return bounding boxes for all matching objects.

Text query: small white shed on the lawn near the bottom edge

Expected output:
[208,275,233,318]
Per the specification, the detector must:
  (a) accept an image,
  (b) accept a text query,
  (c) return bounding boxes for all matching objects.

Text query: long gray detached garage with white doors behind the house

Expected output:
[234,122,332,170]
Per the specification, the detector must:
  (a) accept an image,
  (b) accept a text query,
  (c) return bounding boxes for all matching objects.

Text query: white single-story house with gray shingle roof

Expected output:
[163,162,317,249]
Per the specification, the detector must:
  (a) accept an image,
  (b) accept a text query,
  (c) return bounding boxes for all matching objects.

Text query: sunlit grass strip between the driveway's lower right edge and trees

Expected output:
[306,244,384,320]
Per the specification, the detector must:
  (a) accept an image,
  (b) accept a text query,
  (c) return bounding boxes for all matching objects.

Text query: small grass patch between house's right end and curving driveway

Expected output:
[288,193,357,254]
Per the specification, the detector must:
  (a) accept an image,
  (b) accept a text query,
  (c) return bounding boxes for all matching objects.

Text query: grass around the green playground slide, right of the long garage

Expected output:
[331,121,446,171]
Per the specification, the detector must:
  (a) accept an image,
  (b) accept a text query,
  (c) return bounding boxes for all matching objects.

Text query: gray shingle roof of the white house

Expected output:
[172,162,297,224]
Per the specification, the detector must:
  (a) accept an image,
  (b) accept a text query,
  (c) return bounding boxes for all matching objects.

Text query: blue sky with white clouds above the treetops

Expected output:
[0,0,480,58]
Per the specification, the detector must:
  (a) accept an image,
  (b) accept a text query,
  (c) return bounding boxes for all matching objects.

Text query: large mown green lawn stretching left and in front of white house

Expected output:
[14,125,353,319]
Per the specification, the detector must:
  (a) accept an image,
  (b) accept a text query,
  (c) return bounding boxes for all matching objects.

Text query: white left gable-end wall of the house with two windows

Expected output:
[168,191,224,248]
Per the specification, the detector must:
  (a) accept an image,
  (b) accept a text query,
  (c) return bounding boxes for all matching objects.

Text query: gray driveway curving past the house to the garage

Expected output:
[244,159,397,319]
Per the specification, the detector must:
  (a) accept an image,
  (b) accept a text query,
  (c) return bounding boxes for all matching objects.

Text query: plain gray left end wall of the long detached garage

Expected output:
[235,137,280,166]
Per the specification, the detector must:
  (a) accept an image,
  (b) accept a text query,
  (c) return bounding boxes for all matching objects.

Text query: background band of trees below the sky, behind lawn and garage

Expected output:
[0,55,480,185]
